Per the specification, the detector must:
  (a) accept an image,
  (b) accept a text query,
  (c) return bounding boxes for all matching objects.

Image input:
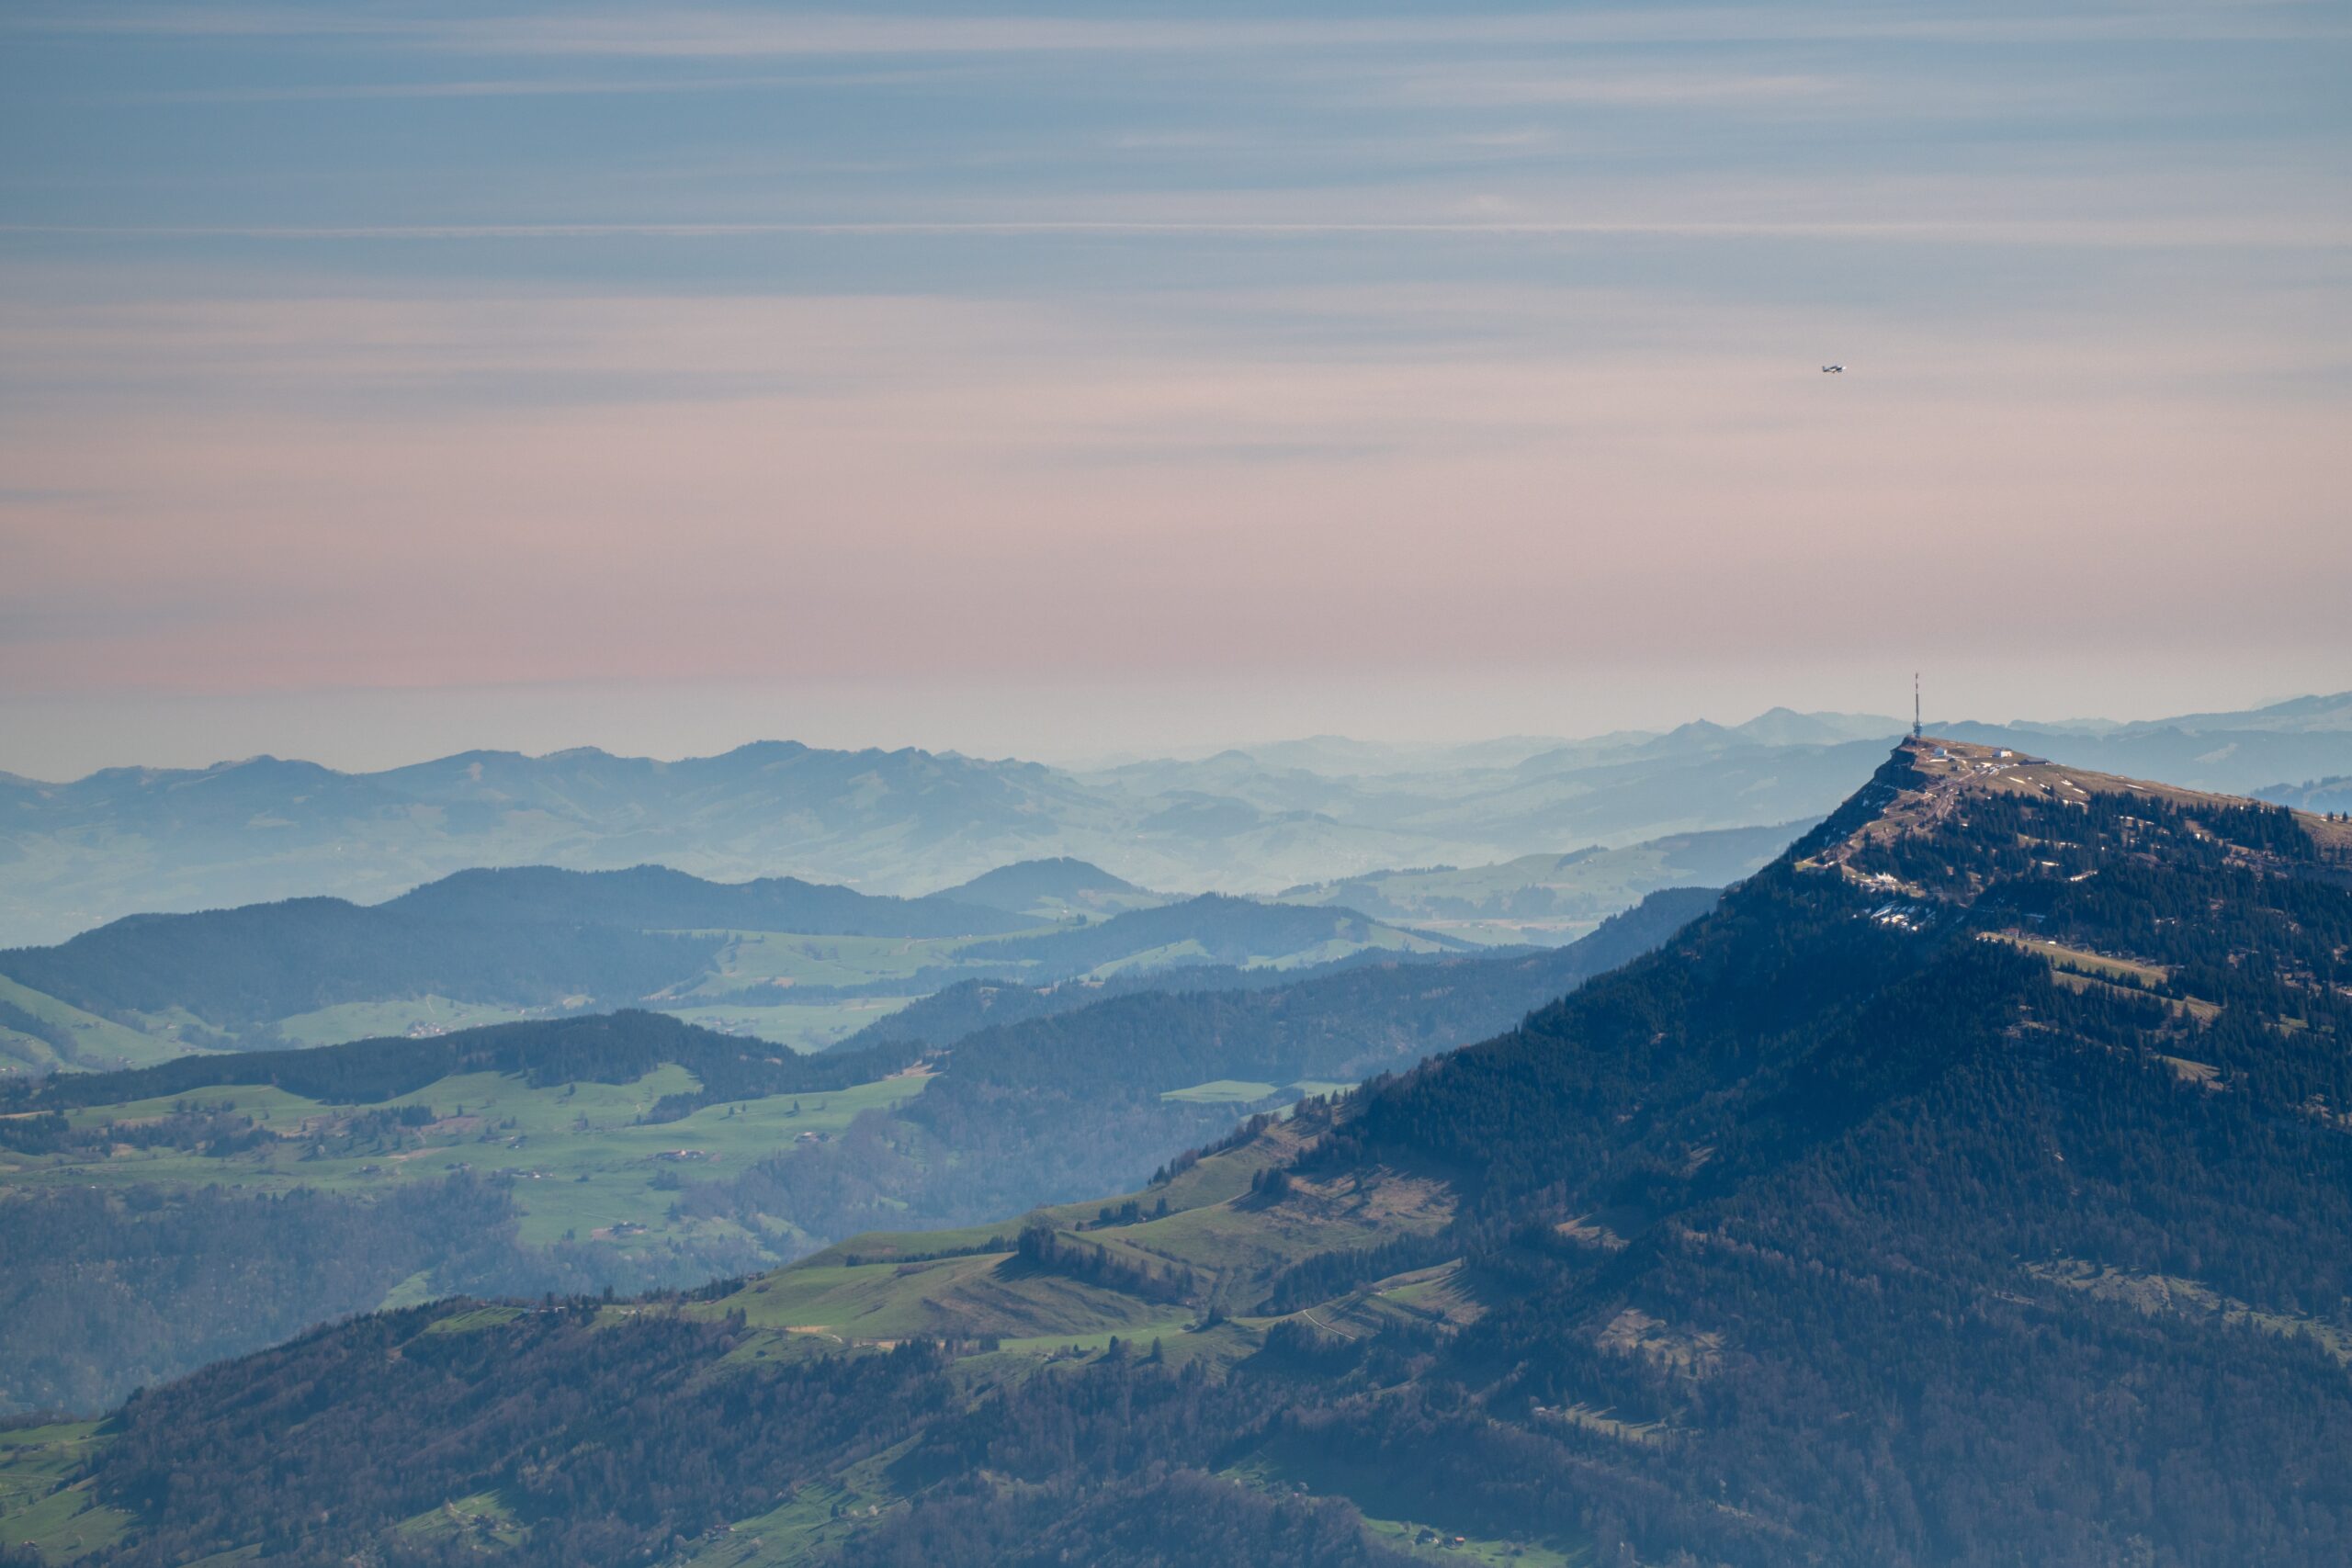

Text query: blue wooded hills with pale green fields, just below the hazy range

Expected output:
[0,865,1453,1069]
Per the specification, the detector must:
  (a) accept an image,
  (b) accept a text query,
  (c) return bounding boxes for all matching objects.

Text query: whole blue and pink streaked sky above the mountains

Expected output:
[0,0,2352,778]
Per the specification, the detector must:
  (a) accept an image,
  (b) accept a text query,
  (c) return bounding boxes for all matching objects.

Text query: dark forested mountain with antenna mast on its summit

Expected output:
[0,740,2352,1568]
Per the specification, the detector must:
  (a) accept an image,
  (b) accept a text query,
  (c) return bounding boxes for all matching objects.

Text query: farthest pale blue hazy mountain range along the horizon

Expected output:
[0,694,2352,942]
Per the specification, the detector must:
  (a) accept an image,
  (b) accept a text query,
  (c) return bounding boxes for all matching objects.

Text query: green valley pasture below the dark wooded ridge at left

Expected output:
[0,1065,929,1246]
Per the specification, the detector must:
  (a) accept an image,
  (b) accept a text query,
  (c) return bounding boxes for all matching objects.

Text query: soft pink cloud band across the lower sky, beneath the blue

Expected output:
[0,294,2352,694]
